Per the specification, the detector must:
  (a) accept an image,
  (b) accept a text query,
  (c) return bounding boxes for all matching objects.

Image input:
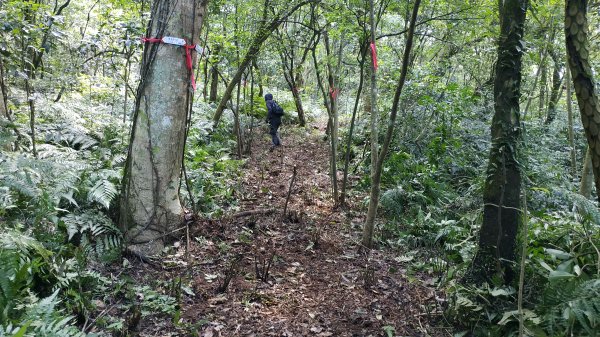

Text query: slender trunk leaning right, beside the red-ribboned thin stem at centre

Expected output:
[362,0,421,249]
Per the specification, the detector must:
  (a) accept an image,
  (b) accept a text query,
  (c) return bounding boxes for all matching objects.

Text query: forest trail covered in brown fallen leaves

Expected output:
[130,123,447,337]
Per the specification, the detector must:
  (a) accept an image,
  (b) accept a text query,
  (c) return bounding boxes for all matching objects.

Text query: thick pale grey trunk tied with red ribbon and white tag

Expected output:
[119,0,208,255]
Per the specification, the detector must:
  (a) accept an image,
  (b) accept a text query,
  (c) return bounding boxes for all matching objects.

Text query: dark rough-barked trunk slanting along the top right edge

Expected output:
[565,0,600,200]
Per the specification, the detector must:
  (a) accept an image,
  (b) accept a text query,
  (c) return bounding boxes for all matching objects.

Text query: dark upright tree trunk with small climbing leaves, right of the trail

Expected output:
[470,0,528,283]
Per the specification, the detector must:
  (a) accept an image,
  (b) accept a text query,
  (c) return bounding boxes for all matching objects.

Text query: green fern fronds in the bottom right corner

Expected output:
[542,279,600,336]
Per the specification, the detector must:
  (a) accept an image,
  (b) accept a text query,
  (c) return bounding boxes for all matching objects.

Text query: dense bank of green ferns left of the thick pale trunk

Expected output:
[0,94,124,336]
